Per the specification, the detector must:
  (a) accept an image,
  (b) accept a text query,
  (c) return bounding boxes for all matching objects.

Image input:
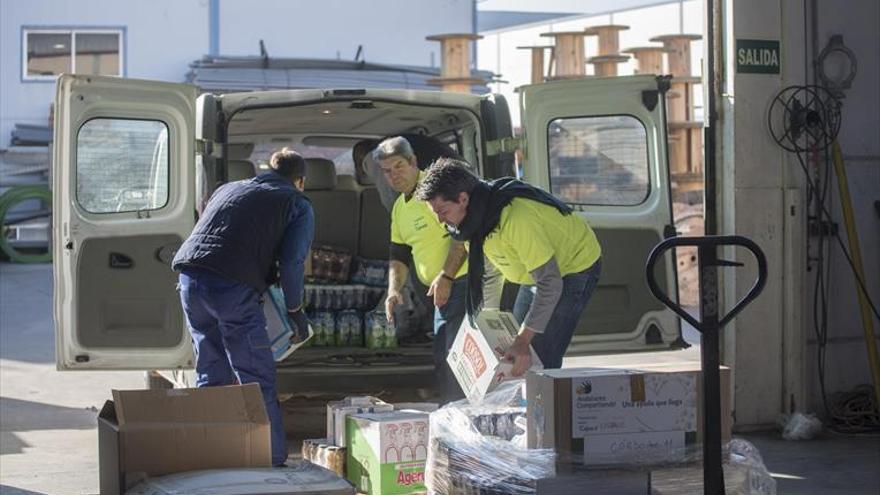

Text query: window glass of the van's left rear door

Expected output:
[76,118,169,213]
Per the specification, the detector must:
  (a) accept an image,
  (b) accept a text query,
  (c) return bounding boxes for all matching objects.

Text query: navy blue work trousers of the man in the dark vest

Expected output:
[179,269,287,466]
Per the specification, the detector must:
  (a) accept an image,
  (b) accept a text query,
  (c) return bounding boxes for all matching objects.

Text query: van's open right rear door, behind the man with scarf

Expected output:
[520,76,681,354]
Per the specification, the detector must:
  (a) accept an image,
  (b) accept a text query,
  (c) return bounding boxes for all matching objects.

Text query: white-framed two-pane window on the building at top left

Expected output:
[23,29,123,80]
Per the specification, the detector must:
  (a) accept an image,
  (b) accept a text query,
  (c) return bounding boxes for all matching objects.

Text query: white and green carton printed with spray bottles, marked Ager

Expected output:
[346,412,428,495]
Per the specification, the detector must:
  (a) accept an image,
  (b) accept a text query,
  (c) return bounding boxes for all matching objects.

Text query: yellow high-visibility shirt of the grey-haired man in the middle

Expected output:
[391,176,467,285]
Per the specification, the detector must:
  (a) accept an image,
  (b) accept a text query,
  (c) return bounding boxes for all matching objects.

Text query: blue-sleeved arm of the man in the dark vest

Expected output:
[279,198,315,312]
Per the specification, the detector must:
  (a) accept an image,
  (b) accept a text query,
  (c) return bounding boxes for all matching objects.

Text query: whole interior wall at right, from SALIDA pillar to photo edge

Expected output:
[719,0,880,427]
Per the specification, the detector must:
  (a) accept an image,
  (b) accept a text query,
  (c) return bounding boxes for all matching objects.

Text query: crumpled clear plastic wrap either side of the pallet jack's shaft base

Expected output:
[651,438,776,495]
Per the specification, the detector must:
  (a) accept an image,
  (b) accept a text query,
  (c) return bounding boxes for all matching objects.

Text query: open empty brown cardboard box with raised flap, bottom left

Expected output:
[98,383,272,495]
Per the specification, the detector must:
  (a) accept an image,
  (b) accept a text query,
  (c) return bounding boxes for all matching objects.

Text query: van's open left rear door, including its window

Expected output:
[52,75,198,369]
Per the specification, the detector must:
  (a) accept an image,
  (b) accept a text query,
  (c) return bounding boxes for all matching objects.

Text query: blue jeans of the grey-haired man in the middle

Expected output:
[434,276,467,404]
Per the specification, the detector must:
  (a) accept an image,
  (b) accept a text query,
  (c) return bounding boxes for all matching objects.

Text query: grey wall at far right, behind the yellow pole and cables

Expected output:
[805,0,880,412]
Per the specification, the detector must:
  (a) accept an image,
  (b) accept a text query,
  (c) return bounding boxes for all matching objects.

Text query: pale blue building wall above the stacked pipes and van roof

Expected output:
[220,0,474,67]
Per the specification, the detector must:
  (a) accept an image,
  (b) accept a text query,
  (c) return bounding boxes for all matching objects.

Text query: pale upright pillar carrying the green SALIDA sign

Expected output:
[720,0,803,429]
